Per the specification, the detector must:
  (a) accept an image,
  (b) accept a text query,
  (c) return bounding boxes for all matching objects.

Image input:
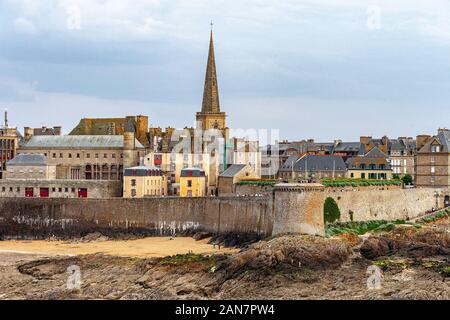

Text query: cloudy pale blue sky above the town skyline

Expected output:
[0,0,450,141]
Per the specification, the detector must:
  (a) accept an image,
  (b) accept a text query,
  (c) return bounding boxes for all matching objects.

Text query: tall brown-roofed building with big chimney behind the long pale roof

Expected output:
[69,115,150,147]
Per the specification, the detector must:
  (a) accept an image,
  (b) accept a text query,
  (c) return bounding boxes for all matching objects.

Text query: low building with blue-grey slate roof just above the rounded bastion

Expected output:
[280,155,347,181]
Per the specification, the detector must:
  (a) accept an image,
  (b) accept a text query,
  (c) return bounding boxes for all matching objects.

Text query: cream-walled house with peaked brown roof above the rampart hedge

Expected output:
[346,147,392,180]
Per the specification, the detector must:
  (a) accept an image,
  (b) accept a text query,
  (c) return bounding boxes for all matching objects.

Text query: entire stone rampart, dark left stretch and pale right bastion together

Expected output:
[0,186,450,239]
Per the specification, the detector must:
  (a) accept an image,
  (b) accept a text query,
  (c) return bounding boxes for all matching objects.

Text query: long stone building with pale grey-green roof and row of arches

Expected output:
[17,132,145,181]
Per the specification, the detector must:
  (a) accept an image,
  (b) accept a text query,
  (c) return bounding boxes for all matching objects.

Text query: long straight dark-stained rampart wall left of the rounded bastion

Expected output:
[0,197,273,238]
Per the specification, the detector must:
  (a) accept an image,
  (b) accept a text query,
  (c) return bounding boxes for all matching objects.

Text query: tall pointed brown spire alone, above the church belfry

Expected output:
[202,30,220,113]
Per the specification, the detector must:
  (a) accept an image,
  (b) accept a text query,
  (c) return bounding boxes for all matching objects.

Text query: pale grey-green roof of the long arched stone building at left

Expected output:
[23,135,144,149]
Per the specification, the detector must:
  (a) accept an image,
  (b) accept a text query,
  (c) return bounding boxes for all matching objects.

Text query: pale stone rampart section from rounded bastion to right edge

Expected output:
[273,187,450,235]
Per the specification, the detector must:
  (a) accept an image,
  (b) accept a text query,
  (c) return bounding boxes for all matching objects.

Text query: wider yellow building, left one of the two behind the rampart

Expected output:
[123,166,167,198]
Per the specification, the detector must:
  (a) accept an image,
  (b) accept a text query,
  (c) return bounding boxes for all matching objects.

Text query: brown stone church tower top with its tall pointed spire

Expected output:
[197,30,227,137]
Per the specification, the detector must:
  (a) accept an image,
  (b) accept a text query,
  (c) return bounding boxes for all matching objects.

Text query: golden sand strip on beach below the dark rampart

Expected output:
[0,237,238,258]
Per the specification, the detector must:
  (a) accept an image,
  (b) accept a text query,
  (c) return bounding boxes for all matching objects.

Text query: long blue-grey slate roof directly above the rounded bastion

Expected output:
[280,155,347,172]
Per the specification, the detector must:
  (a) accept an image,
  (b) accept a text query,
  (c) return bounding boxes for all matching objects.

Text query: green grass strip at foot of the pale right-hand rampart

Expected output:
[326,220,420,237]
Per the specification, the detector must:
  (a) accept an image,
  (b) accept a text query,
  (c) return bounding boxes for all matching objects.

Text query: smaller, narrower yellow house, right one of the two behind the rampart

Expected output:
[180,168,207,197]
